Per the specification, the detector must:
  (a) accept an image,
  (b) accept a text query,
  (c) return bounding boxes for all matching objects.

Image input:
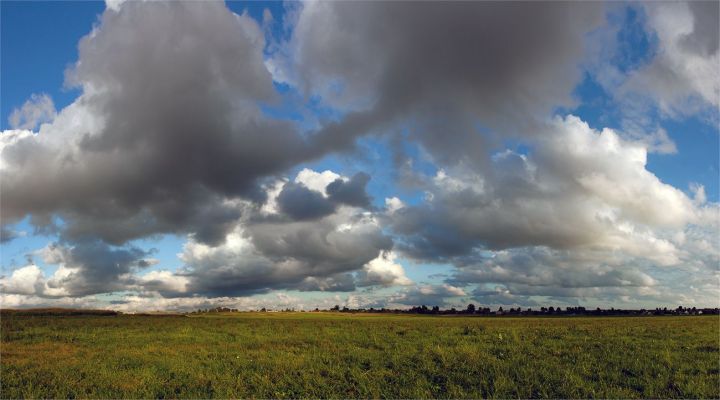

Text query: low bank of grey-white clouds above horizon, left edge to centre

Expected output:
[0,170,402,298]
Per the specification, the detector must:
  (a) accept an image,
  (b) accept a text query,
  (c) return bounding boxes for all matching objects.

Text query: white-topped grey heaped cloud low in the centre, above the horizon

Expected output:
[146,170,396,297]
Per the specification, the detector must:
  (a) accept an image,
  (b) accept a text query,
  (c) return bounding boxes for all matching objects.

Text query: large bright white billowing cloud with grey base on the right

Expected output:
[391,116,701,264]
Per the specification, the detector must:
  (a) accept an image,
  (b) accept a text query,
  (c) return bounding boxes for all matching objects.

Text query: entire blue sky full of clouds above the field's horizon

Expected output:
[0,0,720,312]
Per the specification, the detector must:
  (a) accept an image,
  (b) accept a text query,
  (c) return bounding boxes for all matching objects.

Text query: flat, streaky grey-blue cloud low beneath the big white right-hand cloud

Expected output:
[447,247,661,306]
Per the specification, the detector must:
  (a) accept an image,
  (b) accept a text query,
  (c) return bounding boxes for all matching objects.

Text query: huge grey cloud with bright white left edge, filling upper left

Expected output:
[0,2,309,244]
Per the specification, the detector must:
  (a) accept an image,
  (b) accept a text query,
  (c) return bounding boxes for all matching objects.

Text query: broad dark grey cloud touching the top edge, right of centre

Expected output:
[284,2,603,163]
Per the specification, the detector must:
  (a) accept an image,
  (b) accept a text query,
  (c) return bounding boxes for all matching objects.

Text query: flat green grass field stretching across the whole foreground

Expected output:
[0,313,720,398]
